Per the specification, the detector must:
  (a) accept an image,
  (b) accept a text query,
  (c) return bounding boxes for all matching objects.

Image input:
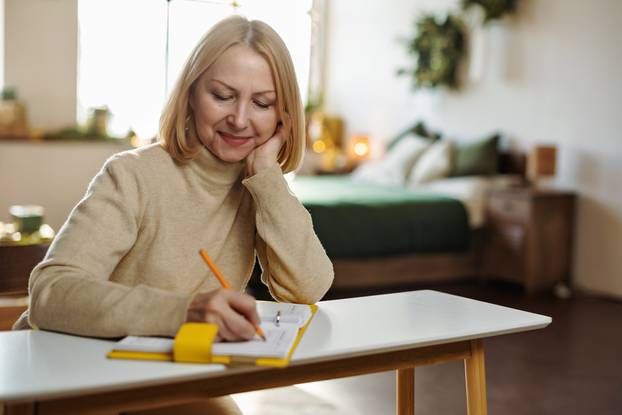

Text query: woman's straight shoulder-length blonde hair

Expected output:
[160,16,305,173]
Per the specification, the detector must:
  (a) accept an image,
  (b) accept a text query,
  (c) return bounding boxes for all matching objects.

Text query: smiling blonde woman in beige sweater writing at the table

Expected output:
[15,13,333,413]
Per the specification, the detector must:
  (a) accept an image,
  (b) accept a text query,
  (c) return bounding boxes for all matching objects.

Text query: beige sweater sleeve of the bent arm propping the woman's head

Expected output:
[243,167,333,304]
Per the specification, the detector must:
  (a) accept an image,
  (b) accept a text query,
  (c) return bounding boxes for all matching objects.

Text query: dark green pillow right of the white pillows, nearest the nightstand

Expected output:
[451,134,500,176]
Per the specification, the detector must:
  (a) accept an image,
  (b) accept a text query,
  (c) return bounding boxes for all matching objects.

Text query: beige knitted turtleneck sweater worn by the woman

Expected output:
[15,144,333,337]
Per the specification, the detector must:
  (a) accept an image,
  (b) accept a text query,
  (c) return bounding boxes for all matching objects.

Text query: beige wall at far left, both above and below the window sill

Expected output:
[0,0,117,230]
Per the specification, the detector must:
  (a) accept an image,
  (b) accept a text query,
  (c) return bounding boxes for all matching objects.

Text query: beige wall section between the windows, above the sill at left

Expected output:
[4,0,78,129]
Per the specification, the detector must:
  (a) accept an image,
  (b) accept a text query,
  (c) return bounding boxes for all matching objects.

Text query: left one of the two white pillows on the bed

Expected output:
[351,134,430,186]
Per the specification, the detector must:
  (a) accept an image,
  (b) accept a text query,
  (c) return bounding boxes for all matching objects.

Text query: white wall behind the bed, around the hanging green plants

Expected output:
[327,0,622,297]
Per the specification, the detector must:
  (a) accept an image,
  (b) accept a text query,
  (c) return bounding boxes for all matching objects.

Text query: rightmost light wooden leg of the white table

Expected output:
[464,339,488,415]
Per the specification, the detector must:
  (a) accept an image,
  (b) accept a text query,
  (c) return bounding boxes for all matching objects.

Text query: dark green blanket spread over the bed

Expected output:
[290,175,470,258]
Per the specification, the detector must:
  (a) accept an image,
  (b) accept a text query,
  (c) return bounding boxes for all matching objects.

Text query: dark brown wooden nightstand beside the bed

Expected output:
[482,187,575,293]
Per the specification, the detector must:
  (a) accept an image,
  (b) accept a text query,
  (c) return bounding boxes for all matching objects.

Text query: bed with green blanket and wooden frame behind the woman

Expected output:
[290,151,522,292]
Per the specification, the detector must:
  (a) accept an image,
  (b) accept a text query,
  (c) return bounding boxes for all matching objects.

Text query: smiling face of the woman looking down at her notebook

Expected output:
[190,45,279,162]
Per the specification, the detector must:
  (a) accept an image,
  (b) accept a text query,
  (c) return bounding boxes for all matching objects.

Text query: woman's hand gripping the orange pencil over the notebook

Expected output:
[186,288,259,341]
